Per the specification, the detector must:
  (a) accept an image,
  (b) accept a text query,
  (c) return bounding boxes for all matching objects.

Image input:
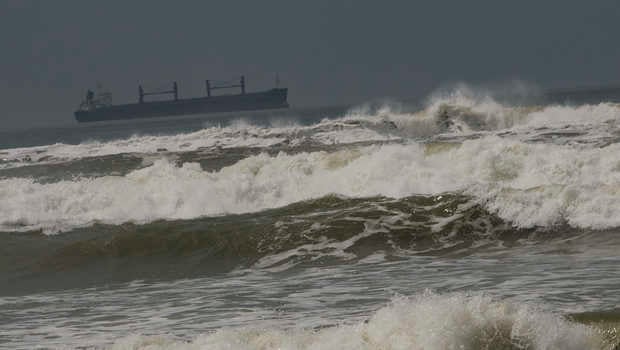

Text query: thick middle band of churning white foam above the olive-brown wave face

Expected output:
[0,136,620,233]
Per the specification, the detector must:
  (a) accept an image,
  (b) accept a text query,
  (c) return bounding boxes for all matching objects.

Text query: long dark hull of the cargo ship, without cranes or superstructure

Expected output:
[75,89,288,122]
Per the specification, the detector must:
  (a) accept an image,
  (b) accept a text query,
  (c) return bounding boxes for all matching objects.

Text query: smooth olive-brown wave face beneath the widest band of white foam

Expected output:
[0,195,532,290]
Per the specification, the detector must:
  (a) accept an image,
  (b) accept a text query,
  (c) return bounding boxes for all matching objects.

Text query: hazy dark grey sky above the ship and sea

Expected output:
[0,0,620,129]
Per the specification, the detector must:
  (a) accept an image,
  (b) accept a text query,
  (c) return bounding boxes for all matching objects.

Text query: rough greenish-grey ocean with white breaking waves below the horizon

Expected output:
[0,89,620,350]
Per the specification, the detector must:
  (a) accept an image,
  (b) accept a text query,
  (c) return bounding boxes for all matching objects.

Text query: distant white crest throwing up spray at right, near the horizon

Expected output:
[358,85,620,137]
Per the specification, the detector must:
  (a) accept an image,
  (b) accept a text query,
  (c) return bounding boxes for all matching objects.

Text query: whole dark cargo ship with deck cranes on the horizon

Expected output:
[74,76,288,122]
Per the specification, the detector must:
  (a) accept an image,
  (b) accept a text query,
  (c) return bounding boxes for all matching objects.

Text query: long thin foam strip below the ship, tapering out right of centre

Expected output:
[0,120,392,168]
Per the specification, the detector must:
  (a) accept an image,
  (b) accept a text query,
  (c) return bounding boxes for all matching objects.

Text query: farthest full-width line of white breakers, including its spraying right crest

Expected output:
[0,86,620,168]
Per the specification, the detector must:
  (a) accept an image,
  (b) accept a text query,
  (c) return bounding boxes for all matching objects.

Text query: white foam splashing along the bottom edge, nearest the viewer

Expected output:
[111,293,606,350]
